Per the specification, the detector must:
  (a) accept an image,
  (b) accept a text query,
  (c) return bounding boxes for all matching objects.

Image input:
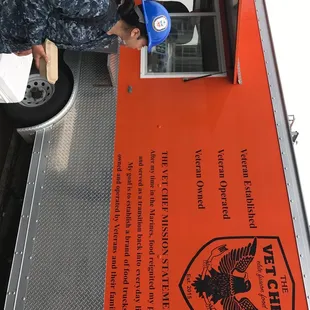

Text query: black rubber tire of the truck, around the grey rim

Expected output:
[4,61,73,128]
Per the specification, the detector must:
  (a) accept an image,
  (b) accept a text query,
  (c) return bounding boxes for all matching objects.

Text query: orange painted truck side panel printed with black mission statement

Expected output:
[105,1,307,309]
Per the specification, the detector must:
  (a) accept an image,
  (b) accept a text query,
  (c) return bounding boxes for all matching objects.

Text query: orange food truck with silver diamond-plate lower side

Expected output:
[1,0,310,310]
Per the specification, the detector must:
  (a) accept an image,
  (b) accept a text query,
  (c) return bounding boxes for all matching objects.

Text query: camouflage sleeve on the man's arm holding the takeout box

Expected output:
[22,0,53,45]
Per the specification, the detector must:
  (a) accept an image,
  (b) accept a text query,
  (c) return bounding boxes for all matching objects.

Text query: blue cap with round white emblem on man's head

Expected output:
[135,0,171,52]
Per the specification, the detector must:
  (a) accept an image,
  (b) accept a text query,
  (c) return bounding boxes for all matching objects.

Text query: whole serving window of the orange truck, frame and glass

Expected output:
[141,0,242,78]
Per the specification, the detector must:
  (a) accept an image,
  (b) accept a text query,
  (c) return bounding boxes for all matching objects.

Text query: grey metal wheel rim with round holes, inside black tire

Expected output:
[20,74,55,108]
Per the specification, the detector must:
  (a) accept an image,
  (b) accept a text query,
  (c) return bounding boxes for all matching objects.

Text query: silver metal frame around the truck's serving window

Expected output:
[140,0,227,79]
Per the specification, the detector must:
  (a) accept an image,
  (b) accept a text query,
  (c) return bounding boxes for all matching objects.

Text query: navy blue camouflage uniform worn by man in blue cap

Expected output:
[0,0,120,53]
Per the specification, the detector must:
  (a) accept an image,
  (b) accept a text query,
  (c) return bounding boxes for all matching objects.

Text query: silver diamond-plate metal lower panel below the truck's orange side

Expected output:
[5,53,118,310]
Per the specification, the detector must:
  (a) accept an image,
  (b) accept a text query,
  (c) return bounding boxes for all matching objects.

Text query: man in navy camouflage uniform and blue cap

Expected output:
[0,0,171,66]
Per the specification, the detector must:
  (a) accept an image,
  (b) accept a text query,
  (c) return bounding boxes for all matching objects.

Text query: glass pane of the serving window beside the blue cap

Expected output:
[147,16,220,73]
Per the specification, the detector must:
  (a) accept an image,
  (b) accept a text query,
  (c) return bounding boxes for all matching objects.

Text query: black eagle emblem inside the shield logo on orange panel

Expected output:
[192,238,258,310]
